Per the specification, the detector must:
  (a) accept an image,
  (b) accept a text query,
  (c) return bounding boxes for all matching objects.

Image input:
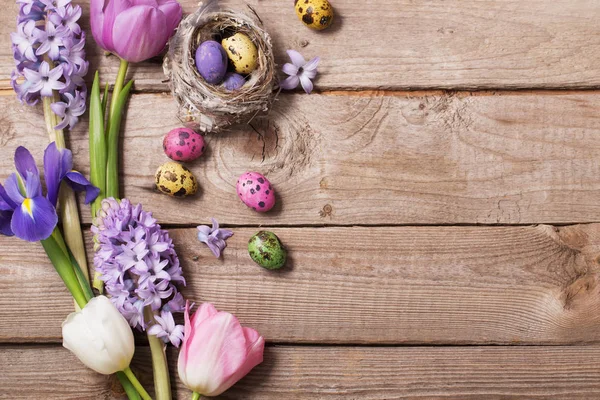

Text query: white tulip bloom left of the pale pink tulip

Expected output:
[62,296,135,375]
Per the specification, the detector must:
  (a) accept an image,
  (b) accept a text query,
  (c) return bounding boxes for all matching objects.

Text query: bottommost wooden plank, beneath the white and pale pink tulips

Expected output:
[0,346,600,400]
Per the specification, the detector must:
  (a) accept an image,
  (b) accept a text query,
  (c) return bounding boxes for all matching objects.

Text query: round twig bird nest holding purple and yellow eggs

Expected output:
[163,1,278,132]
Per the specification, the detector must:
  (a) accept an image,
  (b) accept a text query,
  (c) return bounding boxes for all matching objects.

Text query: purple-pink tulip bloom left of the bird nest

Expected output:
[90,0,182,62]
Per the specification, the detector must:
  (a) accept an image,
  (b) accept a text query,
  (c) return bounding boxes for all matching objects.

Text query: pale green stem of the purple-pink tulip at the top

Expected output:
[106,60,129,199]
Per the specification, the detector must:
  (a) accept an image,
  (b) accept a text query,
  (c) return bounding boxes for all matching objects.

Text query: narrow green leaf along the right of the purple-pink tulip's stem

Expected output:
[106,80,133,198]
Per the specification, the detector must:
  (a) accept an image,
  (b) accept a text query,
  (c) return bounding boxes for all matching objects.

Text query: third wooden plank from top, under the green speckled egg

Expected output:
[0,224,600,344]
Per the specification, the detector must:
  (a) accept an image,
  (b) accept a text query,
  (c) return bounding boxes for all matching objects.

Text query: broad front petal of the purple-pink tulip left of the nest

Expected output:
[112,5,171,63]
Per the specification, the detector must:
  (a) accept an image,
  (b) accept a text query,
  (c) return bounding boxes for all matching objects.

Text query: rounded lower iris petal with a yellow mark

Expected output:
[10,196,58,242]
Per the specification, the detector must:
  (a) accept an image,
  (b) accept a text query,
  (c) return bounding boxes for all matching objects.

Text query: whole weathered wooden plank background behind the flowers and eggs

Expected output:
[0,0,600,400]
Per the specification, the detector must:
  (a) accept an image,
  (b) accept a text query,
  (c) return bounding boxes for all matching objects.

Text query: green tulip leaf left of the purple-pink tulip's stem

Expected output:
[89,72,107,217]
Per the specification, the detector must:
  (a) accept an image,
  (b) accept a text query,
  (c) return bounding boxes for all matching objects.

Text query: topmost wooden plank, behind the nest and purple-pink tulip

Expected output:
[0,0,600,90]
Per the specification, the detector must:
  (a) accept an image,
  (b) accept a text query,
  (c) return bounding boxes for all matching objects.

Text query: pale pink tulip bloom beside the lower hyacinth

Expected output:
[178,303,265,396]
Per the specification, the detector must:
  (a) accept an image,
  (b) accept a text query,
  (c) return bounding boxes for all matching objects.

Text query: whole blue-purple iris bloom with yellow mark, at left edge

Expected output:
[0,142,99,242]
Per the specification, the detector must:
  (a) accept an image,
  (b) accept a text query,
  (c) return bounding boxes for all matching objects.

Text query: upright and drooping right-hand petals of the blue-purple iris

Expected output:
[44,142,100,206]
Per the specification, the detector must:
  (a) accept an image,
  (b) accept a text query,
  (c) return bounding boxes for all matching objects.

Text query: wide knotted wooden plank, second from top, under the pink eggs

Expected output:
[0,92,600,225]
